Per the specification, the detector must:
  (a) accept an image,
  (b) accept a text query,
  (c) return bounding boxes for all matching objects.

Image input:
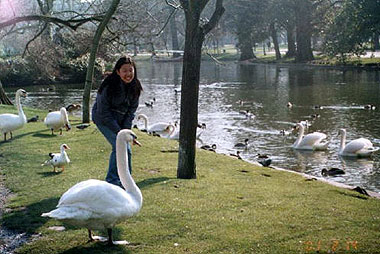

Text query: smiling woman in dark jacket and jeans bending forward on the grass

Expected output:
[92,56,142,186]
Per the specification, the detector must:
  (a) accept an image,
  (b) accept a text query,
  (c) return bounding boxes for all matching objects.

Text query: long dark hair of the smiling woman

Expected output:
[98,56,143,98]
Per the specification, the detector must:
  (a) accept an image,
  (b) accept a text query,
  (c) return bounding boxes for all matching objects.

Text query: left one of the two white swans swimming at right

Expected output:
[293,123,328,151]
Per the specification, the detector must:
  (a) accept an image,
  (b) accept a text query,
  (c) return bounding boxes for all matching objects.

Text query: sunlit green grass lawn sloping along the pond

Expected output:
[0,105,380,254]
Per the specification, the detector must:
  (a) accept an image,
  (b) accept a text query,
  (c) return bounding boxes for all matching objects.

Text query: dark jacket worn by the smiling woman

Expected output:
[92,75,139,133]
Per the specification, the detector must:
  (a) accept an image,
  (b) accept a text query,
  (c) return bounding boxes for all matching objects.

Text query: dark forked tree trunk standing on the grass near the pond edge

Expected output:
[177,0,224,179]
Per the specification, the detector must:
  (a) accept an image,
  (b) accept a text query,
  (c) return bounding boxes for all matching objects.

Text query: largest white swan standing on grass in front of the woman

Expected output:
[42,129,143,245]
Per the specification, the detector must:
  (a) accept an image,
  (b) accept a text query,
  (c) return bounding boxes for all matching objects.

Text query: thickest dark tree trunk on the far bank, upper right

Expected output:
[295,0,314,62]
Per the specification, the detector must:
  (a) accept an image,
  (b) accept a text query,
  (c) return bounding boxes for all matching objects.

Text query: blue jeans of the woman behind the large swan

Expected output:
[96,124,132,188]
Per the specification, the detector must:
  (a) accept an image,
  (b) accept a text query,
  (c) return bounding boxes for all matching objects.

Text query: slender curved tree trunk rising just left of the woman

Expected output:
[82,0,120,123]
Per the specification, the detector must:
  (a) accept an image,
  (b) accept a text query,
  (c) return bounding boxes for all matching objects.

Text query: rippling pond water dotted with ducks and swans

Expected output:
[6,62,380,192]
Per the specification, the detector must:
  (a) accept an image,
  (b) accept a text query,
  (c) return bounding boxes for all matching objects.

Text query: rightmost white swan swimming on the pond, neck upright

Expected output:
[339,129,379,157]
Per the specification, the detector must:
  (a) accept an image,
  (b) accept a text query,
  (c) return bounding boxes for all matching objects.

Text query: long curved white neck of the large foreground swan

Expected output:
[116,138,142,204]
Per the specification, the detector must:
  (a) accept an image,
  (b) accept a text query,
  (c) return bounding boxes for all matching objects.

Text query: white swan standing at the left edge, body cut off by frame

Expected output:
[0,89,26,141]
